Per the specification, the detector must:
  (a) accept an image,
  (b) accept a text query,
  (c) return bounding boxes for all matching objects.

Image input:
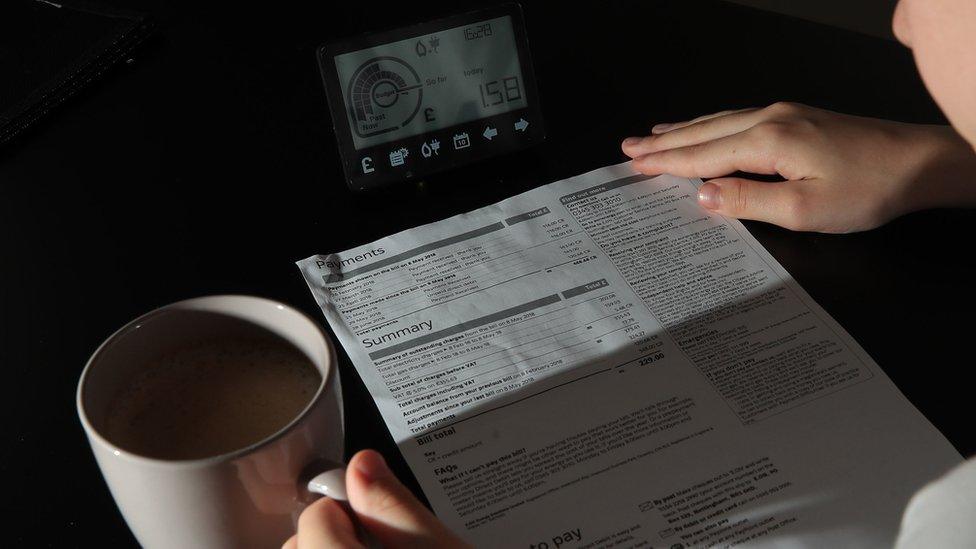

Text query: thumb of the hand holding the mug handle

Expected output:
[346,450,464,547]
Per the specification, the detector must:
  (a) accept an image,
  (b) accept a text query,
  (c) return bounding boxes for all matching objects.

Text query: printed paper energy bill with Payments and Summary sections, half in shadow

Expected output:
[299,164,961,549]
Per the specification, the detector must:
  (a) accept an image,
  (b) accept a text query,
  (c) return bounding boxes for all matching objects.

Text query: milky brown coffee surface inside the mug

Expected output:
[105,338,321,459]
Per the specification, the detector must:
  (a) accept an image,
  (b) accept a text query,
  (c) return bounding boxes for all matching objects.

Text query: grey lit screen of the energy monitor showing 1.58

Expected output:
[335,16,526,149]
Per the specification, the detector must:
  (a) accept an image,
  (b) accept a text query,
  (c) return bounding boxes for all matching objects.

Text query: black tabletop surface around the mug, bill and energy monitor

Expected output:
[0,0,976,547]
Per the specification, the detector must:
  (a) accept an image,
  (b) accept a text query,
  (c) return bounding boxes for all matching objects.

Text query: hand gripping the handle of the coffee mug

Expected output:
[282,450,467,549]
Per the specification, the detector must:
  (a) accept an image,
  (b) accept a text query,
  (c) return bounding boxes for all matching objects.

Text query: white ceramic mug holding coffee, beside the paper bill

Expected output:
[77,296,344,549]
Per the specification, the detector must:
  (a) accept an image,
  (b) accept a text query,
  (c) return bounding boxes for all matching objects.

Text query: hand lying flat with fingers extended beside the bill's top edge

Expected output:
[622,103,976,233]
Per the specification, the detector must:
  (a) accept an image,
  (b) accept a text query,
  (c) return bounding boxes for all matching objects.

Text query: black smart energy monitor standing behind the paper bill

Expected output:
[319,4,545,189]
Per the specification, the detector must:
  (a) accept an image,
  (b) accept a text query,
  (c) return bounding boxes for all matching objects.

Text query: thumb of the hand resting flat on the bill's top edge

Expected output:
[698,177,810,231]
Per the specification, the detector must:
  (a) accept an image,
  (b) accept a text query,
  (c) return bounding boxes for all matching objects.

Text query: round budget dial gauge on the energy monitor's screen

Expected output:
[346,57,424,137]
